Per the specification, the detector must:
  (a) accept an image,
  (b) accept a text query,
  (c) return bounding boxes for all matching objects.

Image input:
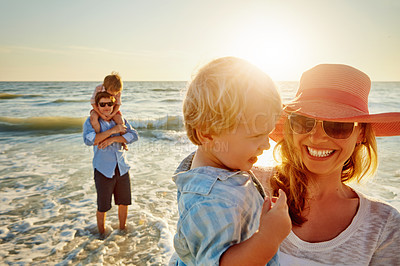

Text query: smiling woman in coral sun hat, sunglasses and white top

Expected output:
[263,64,400,265]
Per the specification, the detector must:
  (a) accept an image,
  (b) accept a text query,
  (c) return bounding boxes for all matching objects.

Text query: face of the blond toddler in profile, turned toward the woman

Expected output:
[211,98,275,171]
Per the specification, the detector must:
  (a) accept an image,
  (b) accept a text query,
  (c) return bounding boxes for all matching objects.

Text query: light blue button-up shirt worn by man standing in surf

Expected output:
[83,118,139,178]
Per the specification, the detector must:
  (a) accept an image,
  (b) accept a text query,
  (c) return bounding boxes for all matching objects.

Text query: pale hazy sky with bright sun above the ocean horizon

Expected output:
[0,0,400,81]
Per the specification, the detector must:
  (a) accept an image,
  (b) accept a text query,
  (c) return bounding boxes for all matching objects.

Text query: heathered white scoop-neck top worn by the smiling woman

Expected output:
[279,191,400,266]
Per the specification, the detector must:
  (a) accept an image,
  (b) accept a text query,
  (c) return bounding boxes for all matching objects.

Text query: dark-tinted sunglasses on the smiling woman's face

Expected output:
[288,113,358,139]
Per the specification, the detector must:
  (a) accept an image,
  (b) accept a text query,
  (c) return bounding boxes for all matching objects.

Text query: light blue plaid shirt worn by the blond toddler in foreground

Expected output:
[170,153,279,265]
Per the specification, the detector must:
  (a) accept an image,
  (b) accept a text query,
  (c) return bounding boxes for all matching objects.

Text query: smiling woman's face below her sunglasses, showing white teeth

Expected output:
[292,118,362,176]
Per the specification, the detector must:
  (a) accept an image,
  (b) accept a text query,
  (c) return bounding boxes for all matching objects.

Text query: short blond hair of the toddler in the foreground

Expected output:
[183,57,282,145]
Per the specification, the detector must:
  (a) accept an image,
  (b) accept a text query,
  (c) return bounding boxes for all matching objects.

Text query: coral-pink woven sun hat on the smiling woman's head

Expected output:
[270,64,400,141]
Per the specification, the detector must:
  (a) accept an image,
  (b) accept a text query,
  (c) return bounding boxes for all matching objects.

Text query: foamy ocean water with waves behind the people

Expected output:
[0,82,400,265]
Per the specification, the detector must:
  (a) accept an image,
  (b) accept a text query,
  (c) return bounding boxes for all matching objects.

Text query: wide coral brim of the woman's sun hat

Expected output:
[270,101,400,142]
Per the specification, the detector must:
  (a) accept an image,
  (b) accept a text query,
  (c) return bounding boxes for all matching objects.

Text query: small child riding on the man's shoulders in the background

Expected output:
[90,72,128,150]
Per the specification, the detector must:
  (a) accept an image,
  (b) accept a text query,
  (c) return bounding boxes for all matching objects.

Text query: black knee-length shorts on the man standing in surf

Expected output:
[94,165,132,212]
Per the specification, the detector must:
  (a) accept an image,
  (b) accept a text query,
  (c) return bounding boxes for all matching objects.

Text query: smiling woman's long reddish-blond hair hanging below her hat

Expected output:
[270,119,378,226]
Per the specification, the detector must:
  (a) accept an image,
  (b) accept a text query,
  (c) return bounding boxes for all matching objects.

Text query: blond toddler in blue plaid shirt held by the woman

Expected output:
[170,57,291,265]
